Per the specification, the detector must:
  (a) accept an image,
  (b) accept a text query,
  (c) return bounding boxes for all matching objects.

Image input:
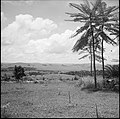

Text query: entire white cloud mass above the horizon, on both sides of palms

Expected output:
[1,14,119,63]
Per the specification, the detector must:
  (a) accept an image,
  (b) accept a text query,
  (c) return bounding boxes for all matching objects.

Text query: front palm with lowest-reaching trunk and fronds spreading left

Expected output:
[66,0,103,88]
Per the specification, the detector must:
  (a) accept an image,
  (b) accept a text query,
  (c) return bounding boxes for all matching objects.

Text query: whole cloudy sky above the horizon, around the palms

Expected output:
[1,0,119,64]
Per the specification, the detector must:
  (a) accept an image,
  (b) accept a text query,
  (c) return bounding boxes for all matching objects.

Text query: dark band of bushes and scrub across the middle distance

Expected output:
[1,65,119,92]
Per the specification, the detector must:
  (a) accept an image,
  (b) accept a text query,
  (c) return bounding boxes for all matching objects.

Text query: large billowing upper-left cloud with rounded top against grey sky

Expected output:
[1,14,57,45]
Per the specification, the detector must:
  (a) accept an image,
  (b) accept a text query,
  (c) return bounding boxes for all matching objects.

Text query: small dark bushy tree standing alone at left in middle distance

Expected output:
[14,65,26,82]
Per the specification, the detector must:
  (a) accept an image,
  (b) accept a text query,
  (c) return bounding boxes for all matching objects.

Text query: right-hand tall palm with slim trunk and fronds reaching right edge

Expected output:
[93,1,119,79]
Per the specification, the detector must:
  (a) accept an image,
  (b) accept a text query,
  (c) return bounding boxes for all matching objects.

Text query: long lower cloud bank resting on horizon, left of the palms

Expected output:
[2,26,78,63]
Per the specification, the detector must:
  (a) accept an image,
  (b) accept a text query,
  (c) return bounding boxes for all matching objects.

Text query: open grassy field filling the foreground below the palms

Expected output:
[1,74,119,118]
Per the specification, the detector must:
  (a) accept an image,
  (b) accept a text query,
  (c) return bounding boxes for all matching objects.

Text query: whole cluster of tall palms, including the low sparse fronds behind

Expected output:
[66,0,119,82]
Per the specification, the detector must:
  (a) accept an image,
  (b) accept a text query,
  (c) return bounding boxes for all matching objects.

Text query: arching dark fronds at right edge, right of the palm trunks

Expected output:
[105,65,119,78]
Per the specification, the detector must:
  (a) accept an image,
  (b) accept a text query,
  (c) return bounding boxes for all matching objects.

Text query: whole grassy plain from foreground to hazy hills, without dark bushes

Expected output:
[1,63,119,118]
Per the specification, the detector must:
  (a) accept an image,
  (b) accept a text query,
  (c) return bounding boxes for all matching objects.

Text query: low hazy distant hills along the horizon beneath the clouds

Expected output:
[1,63,102,71]
